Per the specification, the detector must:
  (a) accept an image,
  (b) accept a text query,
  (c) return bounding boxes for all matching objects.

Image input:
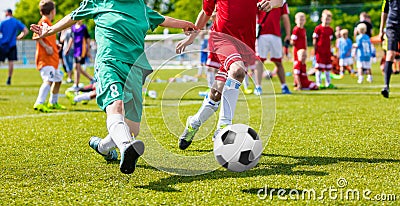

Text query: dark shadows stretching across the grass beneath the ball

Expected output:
[136,154,400,192]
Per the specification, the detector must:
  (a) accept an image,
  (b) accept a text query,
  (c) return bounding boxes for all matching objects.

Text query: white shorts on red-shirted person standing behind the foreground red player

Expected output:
[256,34,282,61]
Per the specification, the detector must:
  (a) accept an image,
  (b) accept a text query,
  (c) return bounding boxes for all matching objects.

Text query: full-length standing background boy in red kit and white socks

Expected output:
[313,9,336,89]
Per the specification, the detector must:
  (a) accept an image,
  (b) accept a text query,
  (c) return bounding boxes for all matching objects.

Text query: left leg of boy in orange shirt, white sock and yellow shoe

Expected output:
[33,66,54,112]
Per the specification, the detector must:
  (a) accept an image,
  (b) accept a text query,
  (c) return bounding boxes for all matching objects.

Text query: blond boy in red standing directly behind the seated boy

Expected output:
[290,12,307,61]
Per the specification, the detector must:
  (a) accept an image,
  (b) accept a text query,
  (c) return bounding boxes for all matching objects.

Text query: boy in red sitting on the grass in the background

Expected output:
[293,49,318,90]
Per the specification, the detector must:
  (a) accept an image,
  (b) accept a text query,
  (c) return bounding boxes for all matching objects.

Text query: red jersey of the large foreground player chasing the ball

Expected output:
[203,0,258,50]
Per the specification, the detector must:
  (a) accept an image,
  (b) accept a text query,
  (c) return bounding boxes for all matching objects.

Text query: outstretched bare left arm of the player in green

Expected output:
[30,15,77,39]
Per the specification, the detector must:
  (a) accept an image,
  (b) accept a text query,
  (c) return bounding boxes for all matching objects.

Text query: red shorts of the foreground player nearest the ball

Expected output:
[208,32,257,81]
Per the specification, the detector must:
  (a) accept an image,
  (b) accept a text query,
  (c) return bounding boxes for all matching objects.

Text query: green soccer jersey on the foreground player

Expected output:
[70,0,165,69]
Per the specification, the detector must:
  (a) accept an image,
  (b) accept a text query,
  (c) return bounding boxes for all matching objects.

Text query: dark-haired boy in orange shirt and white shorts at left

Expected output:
[33,0,65,112]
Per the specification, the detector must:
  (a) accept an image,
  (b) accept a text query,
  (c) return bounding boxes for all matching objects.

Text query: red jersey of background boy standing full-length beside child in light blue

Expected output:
[313,24,333,57]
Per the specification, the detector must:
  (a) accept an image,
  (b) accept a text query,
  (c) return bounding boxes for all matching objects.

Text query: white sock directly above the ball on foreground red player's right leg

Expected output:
[217,77,241,128]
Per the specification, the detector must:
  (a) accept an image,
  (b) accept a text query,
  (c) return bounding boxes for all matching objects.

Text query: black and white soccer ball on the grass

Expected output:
[214,124,263,172]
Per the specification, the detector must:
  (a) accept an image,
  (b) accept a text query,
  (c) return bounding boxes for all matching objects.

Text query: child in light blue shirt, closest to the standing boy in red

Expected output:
[338,29,354,77]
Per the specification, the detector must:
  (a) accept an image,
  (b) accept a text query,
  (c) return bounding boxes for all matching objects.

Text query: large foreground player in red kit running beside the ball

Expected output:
[176,0,283,150]
